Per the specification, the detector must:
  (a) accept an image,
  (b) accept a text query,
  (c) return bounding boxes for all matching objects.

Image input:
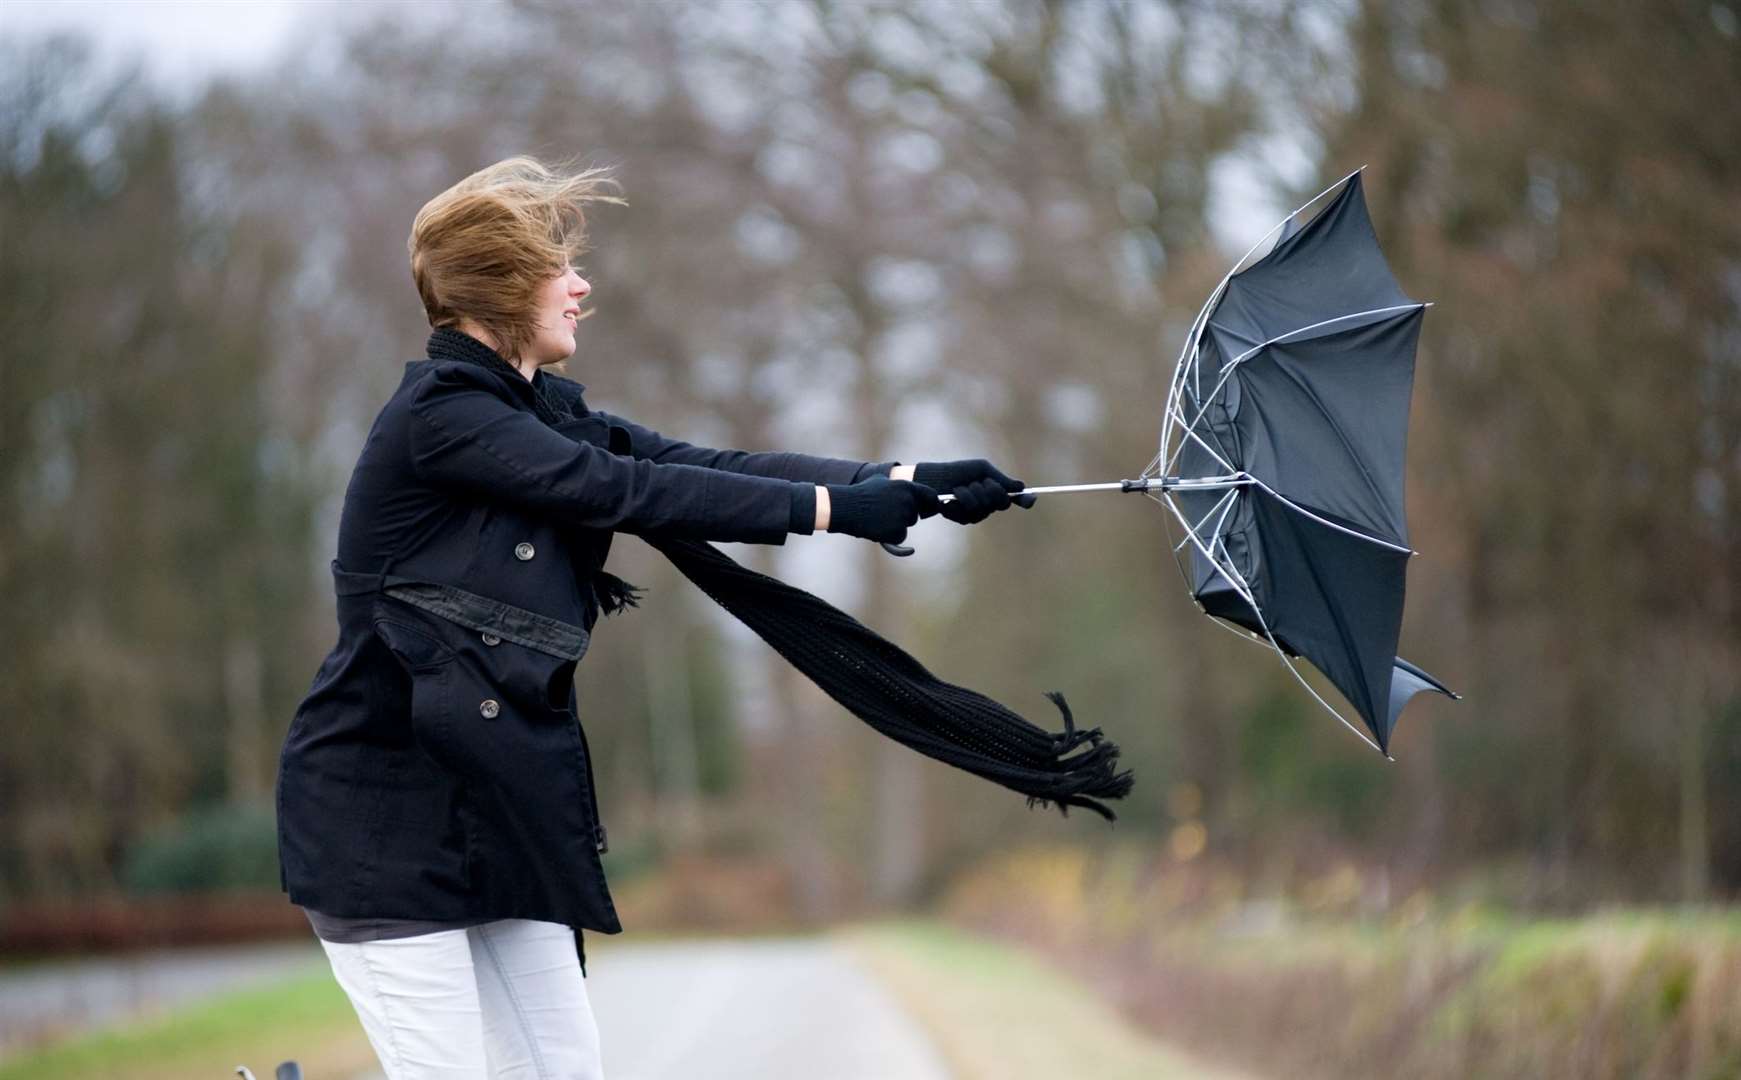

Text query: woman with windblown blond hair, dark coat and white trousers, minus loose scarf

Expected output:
[277,157,1032,1080]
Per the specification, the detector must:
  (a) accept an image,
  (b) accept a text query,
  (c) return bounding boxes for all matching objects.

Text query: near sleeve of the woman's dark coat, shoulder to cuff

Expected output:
[409,364,794,543]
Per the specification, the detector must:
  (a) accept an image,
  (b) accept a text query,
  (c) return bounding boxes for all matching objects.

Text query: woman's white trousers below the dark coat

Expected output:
[320,918,604,1080]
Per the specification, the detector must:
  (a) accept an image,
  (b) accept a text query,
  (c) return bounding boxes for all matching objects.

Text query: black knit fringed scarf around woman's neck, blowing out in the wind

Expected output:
[430,327,1132,820]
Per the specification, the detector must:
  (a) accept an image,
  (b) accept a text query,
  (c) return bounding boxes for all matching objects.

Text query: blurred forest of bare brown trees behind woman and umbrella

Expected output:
[0,0,1741,989]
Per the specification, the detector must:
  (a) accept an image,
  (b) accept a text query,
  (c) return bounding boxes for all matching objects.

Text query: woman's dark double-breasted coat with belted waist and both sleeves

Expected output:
[277,331,890,934]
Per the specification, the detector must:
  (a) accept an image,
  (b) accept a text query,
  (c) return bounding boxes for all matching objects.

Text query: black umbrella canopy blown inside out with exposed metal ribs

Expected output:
[1156,172,1455,753]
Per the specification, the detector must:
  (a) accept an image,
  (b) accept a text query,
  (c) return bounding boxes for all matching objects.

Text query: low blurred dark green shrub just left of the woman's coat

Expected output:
[120,803,279,894]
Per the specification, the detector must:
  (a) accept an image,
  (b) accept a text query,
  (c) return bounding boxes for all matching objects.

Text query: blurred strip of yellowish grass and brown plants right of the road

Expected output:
[944,847,1741,1080]
